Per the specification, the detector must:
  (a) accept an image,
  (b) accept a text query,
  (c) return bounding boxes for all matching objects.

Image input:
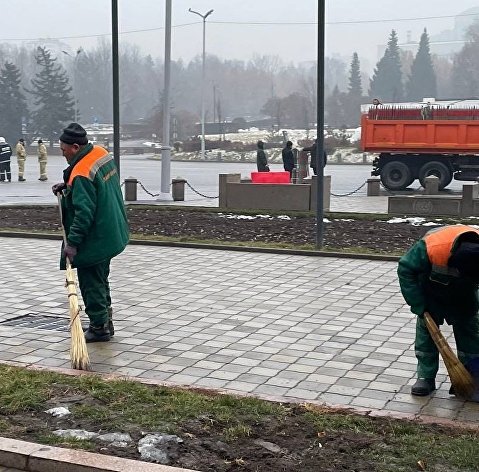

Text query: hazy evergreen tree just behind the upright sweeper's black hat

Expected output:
[29,47,75,146]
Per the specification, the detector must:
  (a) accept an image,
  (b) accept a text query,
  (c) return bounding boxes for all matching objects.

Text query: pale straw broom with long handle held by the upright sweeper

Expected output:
[57,193,90,370]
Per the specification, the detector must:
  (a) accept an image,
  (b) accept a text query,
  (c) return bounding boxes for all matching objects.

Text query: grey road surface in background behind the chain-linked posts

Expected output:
[0,155,402,213]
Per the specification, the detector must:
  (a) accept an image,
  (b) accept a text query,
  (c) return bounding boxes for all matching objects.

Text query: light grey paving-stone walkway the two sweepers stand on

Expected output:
[0,238,479,423]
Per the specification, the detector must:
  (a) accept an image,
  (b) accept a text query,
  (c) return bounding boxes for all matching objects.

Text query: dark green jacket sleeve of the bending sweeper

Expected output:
[398,239,431,315]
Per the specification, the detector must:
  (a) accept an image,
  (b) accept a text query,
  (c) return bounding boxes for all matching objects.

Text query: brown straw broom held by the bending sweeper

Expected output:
[424,312,475,399]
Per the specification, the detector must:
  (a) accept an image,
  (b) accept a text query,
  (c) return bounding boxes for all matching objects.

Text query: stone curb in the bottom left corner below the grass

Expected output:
[0,437,198,472]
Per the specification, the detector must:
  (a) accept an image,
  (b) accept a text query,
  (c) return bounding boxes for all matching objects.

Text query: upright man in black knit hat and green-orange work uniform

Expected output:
[52,123,129,342]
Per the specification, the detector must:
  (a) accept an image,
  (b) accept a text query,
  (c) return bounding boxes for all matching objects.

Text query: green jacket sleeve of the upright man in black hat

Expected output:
[67,176,97,247]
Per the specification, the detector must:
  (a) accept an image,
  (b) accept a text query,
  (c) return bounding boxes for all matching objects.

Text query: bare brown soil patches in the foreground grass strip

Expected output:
[0,402,454,472]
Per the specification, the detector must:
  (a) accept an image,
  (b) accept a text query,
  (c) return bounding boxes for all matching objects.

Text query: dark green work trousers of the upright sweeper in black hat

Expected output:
[77,259,111,326]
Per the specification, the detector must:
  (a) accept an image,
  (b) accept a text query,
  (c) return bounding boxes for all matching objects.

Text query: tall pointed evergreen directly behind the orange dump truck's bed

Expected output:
[407,28,437,101]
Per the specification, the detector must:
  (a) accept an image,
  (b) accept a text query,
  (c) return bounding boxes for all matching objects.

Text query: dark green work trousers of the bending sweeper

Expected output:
[414,315,479,379]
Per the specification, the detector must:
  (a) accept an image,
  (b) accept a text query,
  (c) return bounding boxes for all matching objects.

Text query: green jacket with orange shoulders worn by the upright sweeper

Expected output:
[61,144,129,267]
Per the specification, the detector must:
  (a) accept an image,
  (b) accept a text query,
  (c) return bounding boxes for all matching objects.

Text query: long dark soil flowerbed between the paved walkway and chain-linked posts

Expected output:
[0,206,436,253]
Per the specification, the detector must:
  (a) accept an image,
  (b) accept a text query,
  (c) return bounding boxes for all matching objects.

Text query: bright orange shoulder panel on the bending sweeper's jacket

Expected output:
[423,225,479,276]
